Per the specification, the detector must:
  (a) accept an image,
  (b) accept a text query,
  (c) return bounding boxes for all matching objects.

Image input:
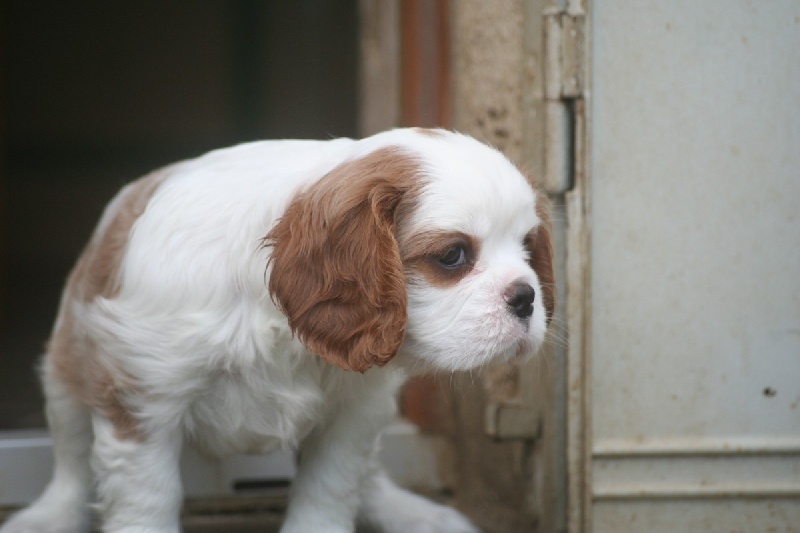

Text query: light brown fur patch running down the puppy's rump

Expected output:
[48,167,172,440]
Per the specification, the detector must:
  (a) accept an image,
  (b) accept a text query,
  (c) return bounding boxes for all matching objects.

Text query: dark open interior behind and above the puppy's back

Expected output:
[0,0,358,429]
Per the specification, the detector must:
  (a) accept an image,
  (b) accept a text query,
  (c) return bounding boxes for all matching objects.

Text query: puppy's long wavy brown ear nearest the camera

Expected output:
[264,148,419,372]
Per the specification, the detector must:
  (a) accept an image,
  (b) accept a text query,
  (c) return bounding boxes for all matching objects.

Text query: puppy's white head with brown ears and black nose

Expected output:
[265,130,554,372]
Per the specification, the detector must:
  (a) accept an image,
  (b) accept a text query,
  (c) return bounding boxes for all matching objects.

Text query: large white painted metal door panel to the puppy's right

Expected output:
[590,0,800,531]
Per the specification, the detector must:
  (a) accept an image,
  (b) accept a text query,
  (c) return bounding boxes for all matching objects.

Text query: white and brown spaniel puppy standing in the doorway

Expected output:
[2,129,553,533]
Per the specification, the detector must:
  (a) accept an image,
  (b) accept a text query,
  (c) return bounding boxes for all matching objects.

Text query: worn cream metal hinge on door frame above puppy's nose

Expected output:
[542,9,586,194]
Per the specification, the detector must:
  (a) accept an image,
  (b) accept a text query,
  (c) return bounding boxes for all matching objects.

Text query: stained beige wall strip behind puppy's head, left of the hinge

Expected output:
[442,0,565,532]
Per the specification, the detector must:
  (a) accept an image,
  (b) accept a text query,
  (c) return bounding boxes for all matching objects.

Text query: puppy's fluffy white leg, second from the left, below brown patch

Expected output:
[91,414,183,533]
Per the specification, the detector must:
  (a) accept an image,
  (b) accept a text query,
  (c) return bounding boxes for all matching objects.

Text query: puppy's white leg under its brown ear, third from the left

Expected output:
[281,392,395,533]
